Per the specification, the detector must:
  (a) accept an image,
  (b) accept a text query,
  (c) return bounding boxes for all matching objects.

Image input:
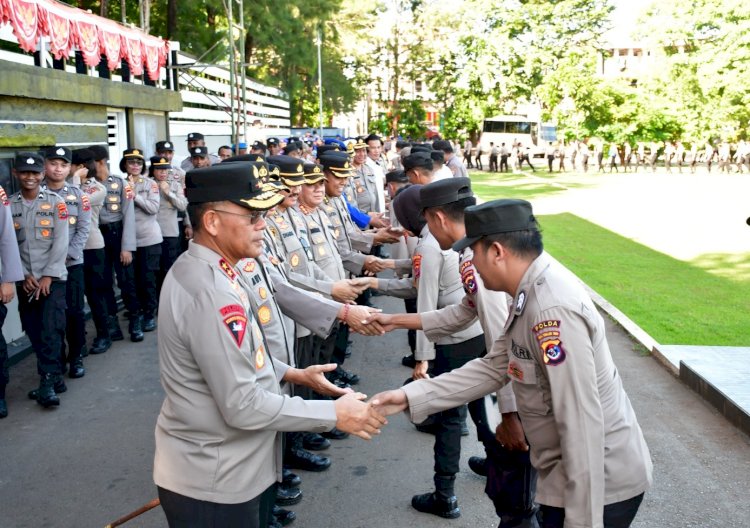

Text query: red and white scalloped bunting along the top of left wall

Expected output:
[0,0,169,80]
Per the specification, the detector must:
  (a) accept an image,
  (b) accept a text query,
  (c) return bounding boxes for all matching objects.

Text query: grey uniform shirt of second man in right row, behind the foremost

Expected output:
[420,248,518,413]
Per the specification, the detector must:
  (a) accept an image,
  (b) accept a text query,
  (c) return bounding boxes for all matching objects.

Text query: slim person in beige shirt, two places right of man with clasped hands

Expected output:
[72,149,112,354]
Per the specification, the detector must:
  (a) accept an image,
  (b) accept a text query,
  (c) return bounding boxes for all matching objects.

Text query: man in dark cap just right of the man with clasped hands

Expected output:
[42,147,91,378]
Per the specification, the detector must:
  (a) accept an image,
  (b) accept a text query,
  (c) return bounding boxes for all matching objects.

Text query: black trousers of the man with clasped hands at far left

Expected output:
[16,281,65,376]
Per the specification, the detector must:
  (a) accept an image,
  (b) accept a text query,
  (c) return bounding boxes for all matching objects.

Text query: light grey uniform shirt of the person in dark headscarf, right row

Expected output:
[378,225,482,361]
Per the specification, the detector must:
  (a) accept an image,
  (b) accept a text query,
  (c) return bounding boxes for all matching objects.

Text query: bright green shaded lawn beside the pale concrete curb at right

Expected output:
[536,213,750,346]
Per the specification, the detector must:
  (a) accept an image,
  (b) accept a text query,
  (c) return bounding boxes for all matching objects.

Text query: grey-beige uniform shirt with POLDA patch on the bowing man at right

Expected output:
[403,253,652,528]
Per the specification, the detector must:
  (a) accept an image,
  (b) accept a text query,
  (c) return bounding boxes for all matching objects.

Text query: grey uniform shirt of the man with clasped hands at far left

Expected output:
[10,189,68,280]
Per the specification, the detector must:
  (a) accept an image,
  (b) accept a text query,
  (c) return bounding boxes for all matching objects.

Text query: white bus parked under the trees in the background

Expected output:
[479,115,557,157]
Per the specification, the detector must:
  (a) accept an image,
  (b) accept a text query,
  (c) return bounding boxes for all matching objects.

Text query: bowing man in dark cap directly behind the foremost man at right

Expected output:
[366,178,538,528]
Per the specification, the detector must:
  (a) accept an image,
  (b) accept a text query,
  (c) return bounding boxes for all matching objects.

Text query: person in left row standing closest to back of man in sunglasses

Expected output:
[148,156,187,290]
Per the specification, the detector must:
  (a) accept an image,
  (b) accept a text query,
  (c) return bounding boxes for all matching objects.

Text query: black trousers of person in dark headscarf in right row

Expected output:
[432,334,485,476]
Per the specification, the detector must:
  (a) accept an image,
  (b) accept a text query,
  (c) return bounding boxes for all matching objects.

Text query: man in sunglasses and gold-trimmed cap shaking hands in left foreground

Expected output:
[154,162,384,528]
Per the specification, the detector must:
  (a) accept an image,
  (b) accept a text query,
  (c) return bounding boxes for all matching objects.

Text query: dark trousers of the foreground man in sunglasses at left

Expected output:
[158,484,276,528]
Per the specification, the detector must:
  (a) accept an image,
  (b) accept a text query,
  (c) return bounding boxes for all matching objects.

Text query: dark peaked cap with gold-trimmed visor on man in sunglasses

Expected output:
[185,161,283,211]
